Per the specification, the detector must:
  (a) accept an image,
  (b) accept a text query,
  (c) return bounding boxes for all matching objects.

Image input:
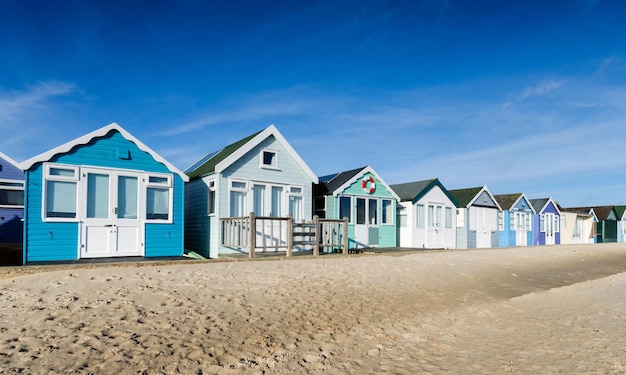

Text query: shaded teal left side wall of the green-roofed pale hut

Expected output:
[185,179,210,257]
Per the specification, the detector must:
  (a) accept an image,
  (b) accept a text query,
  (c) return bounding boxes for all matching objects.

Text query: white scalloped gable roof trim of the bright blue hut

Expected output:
[20,122,189,181]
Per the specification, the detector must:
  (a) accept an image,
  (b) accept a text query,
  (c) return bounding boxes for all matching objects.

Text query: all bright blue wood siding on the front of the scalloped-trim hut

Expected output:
[25,131,184,262]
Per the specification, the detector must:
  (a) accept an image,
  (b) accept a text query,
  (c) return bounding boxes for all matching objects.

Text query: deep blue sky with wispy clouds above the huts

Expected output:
[0,0,626,207]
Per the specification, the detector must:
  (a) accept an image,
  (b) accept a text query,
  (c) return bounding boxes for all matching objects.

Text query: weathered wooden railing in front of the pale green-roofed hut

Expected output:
[220,213,348,258]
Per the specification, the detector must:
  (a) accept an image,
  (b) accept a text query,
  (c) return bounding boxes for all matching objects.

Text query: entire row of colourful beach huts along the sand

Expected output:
[0,123,626,263]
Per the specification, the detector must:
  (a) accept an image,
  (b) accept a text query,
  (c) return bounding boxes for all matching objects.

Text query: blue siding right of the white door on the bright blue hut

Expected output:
[145,174,185,257]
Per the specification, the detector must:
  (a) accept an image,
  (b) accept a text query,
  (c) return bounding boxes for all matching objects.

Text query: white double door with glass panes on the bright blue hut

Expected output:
[80,168,145,258]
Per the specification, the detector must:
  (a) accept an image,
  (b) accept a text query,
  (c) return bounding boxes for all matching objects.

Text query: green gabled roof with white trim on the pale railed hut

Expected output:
[185,125,318,183]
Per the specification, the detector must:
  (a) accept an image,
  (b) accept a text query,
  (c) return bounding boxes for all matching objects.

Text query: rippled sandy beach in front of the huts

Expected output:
[0,244,626,374]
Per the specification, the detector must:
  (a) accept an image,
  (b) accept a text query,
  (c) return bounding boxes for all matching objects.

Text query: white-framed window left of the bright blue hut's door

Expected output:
[43,164,78,221]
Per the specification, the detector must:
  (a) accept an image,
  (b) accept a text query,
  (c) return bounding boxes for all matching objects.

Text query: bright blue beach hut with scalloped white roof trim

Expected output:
[20,123,188,263]
